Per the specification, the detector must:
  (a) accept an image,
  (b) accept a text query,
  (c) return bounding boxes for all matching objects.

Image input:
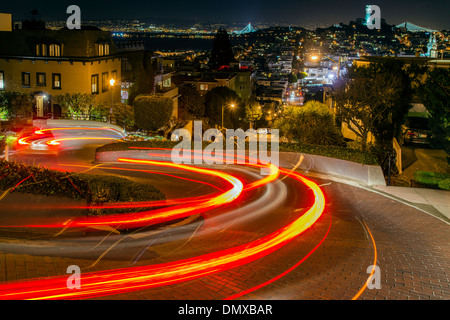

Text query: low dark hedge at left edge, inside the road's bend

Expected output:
[0,160,165,214]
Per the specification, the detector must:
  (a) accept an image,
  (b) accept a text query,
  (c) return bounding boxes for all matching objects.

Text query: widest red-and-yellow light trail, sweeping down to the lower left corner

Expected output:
[0,159,325,299]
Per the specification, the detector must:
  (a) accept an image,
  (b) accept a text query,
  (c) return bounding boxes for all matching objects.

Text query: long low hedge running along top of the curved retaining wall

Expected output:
[97,140,378,165]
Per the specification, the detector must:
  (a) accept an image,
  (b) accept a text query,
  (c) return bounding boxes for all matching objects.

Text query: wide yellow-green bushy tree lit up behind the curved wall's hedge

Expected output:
[274,101,344,145]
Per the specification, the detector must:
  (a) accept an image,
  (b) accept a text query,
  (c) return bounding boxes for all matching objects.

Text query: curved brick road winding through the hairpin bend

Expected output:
[0,138,450,300]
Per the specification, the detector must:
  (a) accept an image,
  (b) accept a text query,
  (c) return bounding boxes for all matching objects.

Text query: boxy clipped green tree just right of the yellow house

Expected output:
[134,95,173,131]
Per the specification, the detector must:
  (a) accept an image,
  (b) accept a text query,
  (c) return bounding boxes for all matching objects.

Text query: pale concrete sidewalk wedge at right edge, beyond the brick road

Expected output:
[373,186,450,223]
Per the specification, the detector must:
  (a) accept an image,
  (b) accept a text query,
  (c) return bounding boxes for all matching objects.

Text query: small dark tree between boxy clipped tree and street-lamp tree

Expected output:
[178,83,205,119]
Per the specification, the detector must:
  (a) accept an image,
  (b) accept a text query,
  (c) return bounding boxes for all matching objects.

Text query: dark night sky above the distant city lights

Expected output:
[0,0,450,29]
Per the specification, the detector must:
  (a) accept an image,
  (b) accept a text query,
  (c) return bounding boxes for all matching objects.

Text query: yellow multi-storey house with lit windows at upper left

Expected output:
[0,16,121,118]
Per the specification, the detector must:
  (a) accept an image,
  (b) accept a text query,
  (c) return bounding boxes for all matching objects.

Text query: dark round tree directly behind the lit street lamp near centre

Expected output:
[205,87,245,128]
